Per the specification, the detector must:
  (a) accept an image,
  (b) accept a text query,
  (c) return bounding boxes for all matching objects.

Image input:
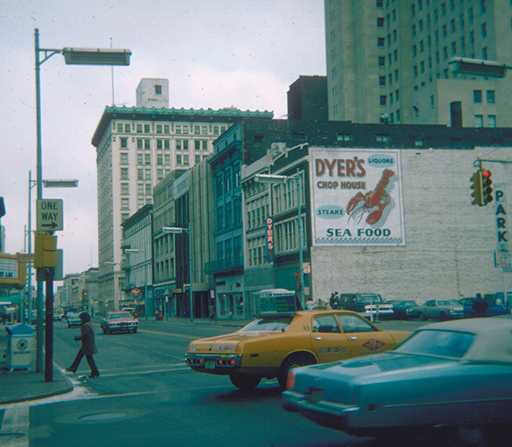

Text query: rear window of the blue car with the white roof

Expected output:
[395,330,475,358]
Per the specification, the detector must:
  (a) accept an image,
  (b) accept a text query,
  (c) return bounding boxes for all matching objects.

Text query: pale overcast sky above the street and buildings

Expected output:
[0,0,325,274]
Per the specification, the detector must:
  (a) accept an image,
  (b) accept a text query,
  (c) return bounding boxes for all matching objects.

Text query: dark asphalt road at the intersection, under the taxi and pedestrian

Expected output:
[0,322,440,447]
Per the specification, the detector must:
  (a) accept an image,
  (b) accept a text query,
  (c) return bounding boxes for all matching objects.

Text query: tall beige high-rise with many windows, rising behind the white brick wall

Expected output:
[325,0,512,127]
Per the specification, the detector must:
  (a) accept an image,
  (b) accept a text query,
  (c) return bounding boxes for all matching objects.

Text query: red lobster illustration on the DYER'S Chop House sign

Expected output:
[347,169,395,225]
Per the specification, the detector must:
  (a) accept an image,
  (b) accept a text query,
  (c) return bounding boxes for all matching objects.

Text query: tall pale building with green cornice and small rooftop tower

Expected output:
[92,79,273,310]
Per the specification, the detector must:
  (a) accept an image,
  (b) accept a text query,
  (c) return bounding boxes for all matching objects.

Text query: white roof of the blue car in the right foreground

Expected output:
[418,315,512,364]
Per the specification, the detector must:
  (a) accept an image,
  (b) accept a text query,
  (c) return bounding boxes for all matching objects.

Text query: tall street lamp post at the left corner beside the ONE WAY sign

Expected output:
[34,28,132,382]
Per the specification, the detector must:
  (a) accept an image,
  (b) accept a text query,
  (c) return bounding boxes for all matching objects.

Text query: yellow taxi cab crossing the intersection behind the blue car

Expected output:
[185,290,410,390]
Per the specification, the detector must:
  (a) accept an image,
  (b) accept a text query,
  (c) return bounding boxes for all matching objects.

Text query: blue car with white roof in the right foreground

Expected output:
[283,316,512,446]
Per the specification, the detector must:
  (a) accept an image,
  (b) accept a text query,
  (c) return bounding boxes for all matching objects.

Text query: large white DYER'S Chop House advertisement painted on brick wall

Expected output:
[310,148,405,246]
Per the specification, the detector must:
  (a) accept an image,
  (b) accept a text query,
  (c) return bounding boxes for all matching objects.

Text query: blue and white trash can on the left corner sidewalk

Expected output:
[5,323,35,372]
